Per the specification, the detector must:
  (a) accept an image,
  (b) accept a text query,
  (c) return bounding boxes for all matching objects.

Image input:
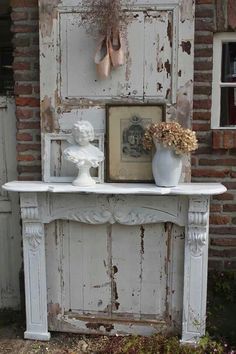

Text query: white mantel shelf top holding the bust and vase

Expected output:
[3,181,226,195]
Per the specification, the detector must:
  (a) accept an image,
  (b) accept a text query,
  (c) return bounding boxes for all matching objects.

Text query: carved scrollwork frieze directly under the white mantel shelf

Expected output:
[47,196,185,226]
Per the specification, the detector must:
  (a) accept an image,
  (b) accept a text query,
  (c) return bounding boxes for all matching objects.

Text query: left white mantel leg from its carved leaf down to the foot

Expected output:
[23,218,50,340]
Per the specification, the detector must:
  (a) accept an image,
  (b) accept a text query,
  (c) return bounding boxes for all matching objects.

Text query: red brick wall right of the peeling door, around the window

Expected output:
[192,0,236,269]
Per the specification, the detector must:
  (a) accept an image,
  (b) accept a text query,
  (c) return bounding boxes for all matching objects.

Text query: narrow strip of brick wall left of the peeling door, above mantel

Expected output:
[11,0,41,180]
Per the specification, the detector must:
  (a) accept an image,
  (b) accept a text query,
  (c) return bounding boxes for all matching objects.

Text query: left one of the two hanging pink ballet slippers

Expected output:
[94,37,111,80]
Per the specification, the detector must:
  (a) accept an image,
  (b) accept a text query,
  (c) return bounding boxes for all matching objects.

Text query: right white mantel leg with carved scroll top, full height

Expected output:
[182,196,209,343]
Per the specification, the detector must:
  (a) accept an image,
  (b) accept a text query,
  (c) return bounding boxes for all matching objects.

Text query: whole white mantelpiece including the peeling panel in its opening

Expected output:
[4,182,226,343]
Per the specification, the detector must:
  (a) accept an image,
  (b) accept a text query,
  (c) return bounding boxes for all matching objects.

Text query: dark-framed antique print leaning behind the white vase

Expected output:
[106,104,165,182]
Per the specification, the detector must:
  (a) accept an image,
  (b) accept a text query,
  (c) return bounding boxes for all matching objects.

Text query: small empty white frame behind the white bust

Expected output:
[42,132,104,183]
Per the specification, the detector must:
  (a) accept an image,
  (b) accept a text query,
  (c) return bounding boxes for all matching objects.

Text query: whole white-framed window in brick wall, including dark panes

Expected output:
[212,33,236,129]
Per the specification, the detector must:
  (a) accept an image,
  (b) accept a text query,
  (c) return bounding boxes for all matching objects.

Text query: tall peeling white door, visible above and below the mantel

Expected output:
[39,0,194,333]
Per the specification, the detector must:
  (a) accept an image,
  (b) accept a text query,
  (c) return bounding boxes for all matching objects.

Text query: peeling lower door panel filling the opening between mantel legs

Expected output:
[46,221,184,334]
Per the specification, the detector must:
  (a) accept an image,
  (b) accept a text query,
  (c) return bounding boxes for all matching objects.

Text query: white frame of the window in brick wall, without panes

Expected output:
[211,32,236,130]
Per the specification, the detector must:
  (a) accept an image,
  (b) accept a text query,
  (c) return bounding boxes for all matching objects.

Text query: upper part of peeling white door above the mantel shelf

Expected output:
[39,0,194,181]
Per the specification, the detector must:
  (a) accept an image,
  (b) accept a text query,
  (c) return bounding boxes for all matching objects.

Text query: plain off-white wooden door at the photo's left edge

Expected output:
[0,96,21,309]
